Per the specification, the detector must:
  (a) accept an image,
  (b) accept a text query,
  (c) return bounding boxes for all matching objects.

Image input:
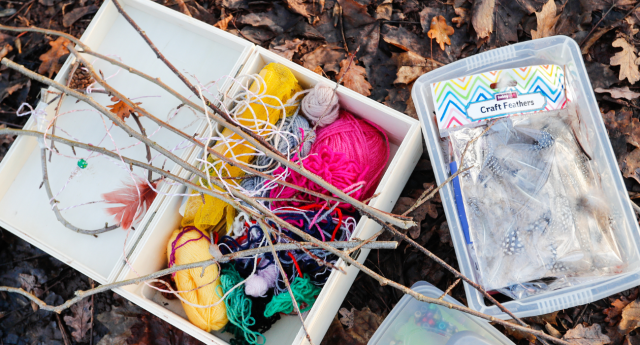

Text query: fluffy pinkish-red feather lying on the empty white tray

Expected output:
[102,180,158,230]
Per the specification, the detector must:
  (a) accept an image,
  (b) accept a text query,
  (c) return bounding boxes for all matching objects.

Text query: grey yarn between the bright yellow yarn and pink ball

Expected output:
[240,116,315,197]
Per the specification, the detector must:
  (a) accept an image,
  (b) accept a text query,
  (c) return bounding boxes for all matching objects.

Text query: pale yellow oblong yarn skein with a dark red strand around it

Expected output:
[167,227,228,332]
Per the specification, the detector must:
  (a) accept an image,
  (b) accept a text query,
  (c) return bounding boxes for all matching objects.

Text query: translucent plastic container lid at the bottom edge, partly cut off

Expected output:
[369,281,513,345]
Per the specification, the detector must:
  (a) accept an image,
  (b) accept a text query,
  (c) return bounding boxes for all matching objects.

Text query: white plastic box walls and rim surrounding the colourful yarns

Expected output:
[116,47,422,345]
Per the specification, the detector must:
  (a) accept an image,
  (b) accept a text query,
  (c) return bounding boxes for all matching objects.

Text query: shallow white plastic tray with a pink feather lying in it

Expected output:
[0,0,253,283]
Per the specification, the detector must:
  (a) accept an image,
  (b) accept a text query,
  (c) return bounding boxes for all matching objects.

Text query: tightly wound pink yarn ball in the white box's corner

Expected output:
[309,110,389,199]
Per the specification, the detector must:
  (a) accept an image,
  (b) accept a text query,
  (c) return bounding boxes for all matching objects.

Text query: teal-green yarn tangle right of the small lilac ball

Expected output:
[262,274,322,317]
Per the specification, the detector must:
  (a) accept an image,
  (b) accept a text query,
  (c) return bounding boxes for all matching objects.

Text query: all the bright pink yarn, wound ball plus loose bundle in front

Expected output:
[270,110,389,211]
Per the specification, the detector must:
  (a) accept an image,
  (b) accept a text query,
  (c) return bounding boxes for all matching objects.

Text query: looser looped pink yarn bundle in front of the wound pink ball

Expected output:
[269,145,369,210]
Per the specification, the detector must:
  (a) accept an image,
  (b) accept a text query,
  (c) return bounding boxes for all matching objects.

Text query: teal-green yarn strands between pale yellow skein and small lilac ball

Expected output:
[220,265,267,345]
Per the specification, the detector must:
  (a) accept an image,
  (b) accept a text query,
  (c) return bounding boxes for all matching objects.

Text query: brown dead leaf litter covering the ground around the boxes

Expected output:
[0,0,640,345]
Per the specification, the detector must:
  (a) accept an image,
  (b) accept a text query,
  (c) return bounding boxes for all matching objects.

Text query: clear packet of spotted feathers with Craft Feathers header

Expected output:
[431,65,625,299]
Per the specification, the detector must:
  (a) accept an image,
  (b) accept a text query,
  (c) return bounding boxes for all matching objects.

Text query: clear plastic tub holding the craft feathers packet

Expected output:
[411,36,640,319]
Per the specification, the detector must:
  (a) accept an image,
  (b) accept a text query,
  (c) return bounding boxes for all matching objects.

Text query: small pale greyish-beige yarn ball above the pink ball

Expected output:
[301,83,340,127]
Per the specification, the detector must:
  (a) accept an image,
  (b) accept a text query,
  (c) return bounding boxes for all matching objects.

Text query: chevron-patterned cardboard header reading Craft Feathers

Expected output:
[431,65,567,137]
